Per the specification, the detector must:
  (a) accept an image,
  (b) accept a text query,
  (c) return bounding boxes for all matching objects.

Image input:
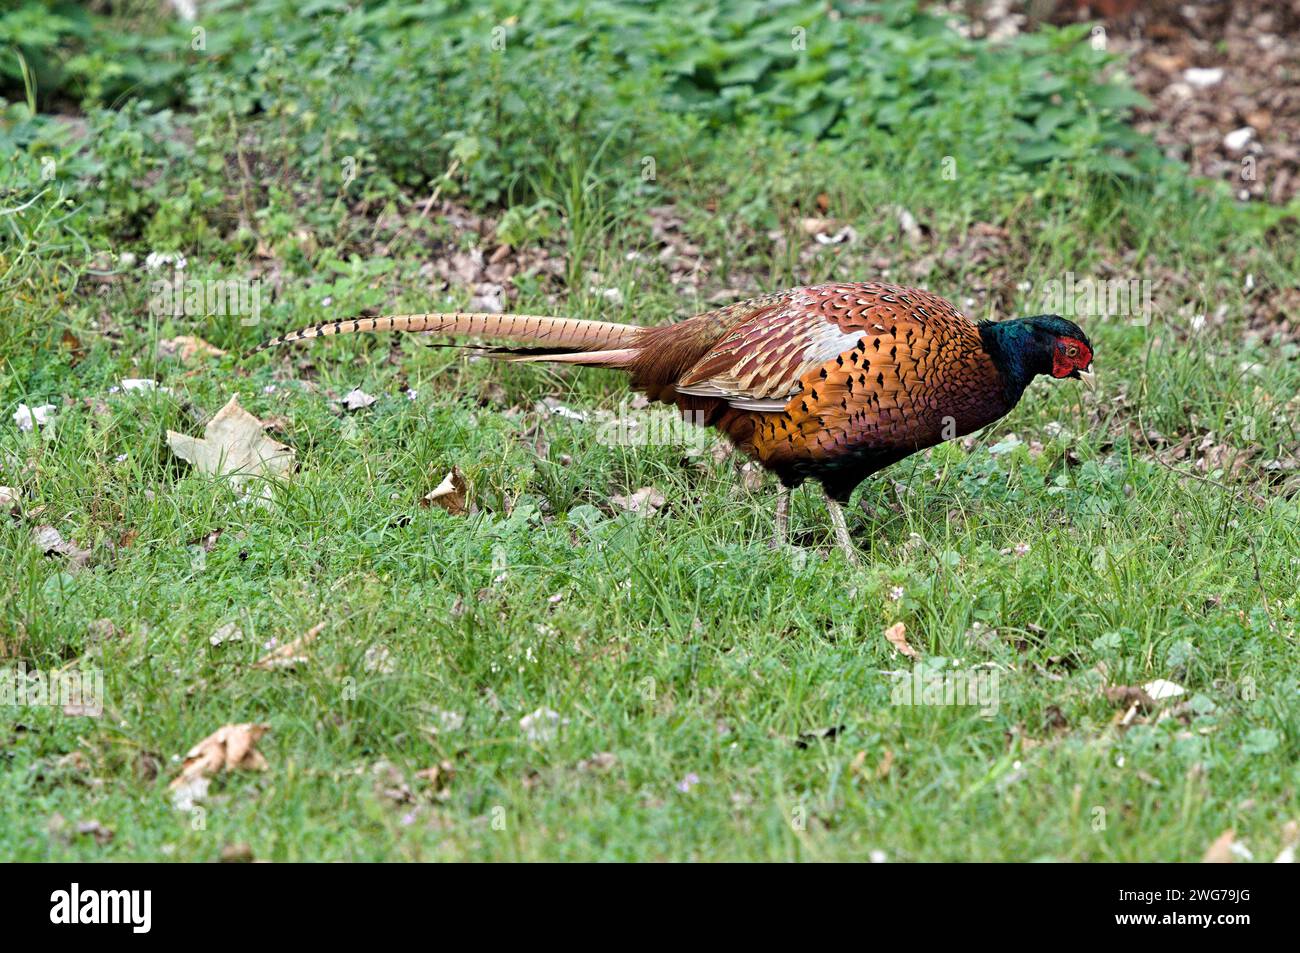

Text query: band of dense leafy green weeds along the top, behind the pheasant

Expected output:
[0,0,1206,251]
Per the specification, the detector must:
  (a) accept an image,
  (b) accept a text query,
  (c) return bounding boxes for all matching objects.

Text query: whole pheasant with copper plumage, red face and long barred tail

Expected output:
[256,282,1092,563]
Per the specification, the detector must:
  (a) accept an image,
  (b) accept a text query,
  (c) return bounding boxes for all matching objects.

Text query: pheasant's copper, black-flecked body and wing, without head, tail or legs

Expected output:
[632,282,1006,502]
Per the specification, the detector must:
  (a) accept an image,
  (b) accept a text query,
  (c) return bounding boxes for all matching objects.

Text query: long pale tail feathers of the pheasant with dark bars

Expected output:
[250,311,642,363]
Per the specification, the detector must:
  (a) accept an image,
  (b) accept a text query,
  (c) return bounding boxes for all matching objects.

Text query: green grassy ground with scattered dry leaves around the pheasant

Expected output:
[0,0,1300,861]
